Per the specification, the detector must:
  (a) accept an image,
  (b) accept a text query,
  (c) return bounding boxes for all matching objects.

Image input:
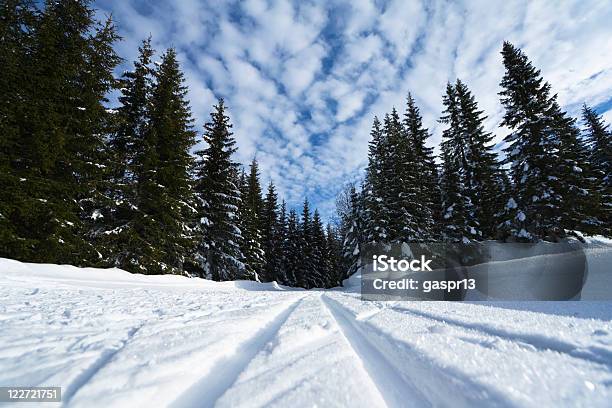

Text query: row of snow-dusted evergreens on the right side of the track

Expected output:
[339,42,612,271]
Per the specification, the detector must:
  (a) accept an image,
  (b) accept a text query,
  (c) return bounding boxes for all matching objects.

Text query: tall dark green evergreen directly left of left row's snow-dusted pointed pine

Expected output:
[128,49,196,274]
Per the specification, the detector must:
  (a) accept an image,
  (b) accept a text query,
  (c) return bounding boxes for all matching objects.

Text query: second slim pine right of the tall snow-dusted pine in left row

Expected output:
[261,181,284,282]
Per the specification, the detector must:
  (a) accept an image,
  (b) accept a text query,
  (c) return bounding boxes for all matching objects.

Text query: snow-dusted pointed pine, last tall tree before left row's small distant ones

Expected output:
[195,99,245,280]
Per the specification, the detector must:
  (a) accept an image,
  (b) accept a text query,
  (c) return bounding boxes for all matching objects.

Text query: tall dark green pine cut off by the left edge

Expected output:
[0,0,38,260]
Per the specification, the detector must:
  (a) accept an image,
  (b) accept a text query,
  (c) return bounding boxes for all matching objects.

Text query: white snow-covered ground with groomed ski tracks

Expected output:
[0,250,612,407]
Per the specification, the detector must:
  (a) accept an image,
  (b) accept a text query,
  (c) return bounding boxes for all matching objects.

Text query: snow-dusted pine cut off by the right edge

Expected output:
[582,104,612,236]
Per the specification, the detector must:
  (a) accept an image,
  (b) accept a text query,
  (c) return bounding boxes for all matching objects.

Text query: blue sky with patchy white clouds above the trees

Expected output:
[94,0,612,222]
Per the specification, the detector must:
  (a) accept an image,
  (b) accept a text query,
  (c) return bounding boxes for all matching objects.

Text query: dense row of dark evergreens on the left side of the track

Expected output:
[0,0,343,288]
